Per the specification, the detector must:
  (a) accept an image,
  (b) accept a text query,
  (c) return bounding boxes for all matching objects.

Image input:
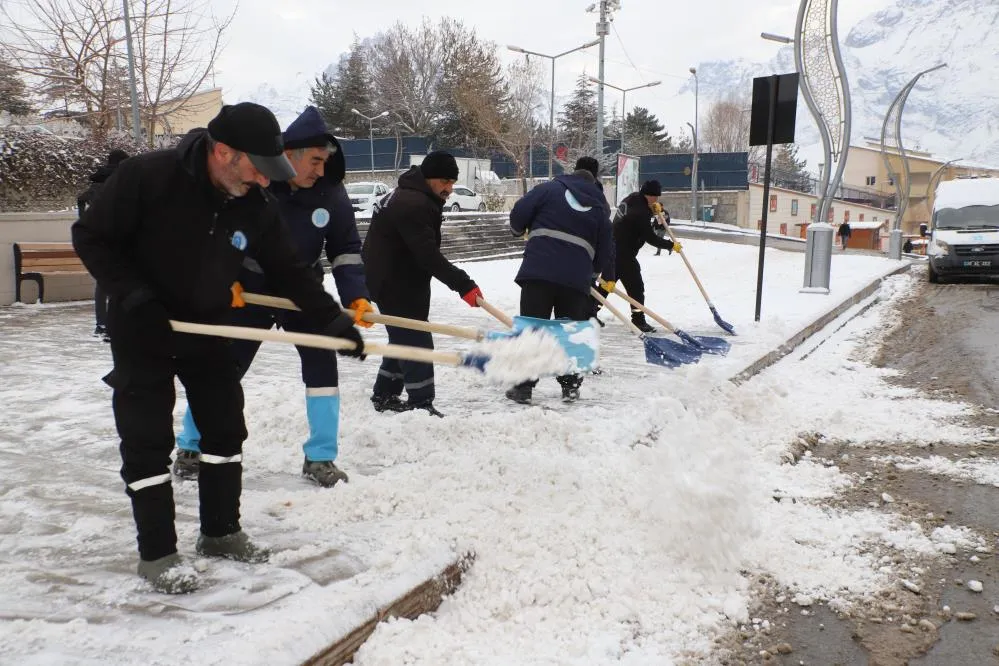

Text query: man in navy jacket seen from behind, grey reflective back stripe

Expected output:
[506,158,614,404]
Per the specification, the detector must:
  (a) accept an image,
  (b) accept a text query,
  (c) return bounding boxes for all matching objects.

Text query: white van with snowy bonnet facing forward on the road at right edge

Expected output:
[920,178,999,282]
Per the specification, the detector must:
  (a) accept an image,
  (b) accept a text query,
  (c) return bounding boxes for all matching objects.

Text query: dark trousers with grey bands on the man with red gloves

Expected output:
[372,284,436,405]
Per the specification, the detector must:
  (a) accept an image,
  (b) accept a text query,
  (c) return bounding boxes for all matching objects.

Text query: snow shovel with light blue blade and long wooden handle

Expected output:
[233,285,599,372]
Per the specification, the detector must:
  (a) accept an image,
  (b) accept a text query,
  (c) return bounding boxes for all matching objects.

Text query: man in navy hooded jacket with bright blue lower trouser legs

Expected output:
[173,106,373,487]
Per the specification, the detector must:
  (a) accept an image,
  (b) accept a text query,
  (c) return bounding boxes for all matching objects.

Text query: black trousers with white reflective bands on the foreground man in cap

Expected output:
[105,308,246,560]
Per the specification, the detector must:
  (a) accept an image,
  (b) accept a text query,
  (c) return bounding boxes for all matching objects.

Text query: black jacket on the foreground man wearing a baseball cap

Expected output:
[72,130,340,327]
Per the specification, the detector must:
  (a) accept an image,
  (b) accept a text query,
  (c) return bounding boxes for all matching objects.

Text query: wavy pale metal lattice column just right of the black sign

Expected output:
[794,0,850,222]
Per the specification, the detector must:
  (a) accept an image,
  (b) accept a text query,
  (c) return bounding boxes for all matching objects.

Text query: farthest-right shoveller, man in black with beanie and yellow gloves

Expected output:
[597,180,679,333]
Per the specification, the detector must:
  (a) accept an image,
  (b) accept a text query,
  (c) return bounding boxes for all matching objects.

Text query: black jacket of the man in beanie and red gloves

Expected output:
[361,166,475,302]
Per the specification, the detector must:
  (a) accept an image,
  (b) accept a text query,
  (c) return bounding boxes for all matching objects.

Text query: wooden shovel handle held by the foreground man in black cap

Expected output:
[170,320,462,366]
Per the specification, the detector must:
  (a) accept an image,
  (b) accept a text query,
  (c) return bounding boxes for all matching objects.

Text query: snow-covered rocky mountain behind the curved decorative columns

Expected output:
[681,0,999,170]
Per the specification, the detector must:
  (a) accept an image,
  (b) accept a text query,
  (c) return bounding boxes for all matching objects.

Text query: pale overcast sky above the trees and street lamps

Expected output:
[212,0,889,134]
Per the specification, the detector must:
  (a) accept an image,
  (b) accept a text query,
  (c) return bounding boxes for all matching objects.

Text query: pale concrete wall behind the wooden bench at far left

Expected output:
[0,212,94,305]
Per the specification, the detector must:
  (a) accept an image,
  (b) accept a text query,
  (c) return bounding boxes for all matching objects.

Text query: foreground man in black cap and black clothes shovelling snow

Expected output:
[72,103,364,594]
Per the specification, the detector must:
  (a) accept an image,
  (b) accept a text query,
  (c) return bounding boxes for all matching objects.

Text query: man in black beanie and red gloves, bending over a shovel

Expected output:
[362,151,482,416]
